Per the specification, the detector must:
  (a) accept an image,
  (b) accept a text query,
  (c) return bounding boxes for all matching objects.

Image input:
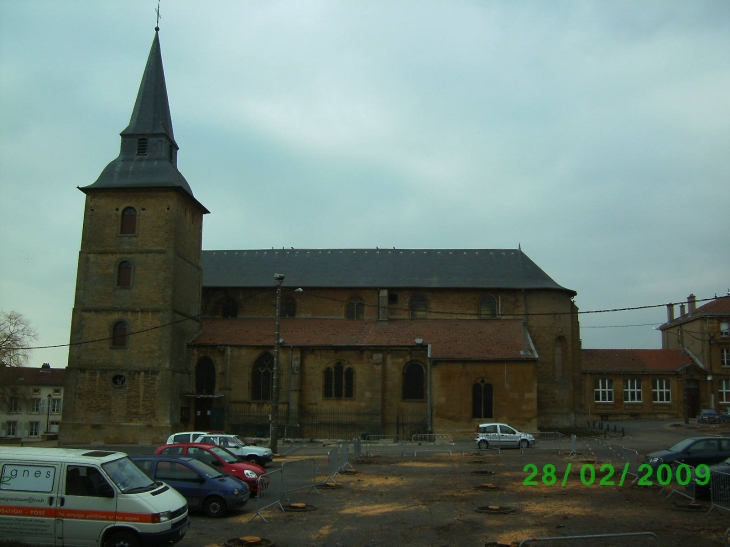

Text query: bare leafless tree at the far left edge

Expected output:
[0,311,38,409]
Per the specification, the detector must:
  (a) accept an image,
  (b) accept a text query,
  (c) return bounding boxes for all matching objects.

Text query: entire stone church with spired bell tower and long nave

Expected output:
[59,30,582,444]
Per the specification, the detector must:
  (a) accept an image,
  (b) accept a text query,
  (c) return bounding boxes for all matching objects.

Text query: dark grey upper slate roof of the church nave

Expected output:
[202,249,576,296]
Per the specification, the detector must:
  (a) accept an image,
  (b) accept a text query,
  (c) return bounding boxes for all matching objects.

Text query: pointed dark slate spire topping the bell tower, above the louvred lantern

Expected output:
[121,30,175,143]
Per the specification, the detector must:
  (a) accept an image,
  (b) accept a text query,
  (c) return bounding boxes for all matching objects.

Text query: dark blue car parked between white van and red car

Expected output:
[130,455,250,517]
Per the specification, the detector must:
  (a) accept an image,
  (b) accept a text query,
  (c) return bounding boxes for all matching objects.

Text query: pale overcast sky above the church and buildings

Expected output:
[0,0,730,366]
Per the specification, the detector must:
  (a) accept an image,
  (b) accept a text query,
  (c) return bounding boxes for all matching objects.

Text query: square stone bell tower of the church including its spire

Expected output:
[59,29,208,444]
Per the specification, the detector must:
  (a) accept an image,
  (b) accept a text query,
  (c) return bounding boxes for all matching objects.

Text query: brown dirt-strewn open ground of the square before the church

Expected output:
[178,450,730,547]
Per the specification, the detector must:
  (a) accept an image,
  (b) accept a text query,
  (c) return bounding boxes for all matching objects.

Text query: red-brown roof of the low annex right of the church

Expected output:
[581,349,692,372]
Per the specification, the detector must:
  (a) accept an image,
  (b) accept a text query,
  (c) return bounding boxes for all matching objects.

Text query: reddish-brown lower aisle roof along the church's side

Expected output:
[189,318,535,361]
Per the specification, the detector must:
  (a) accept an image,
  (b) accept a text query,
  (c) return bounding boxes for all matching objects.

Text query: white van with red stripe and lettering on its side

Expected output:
[0,447,190,547]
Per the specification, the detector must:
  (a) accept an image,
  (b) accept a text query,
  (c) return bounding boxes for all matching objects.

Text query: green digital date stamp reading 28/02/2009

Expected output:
[522,462,710,486]
